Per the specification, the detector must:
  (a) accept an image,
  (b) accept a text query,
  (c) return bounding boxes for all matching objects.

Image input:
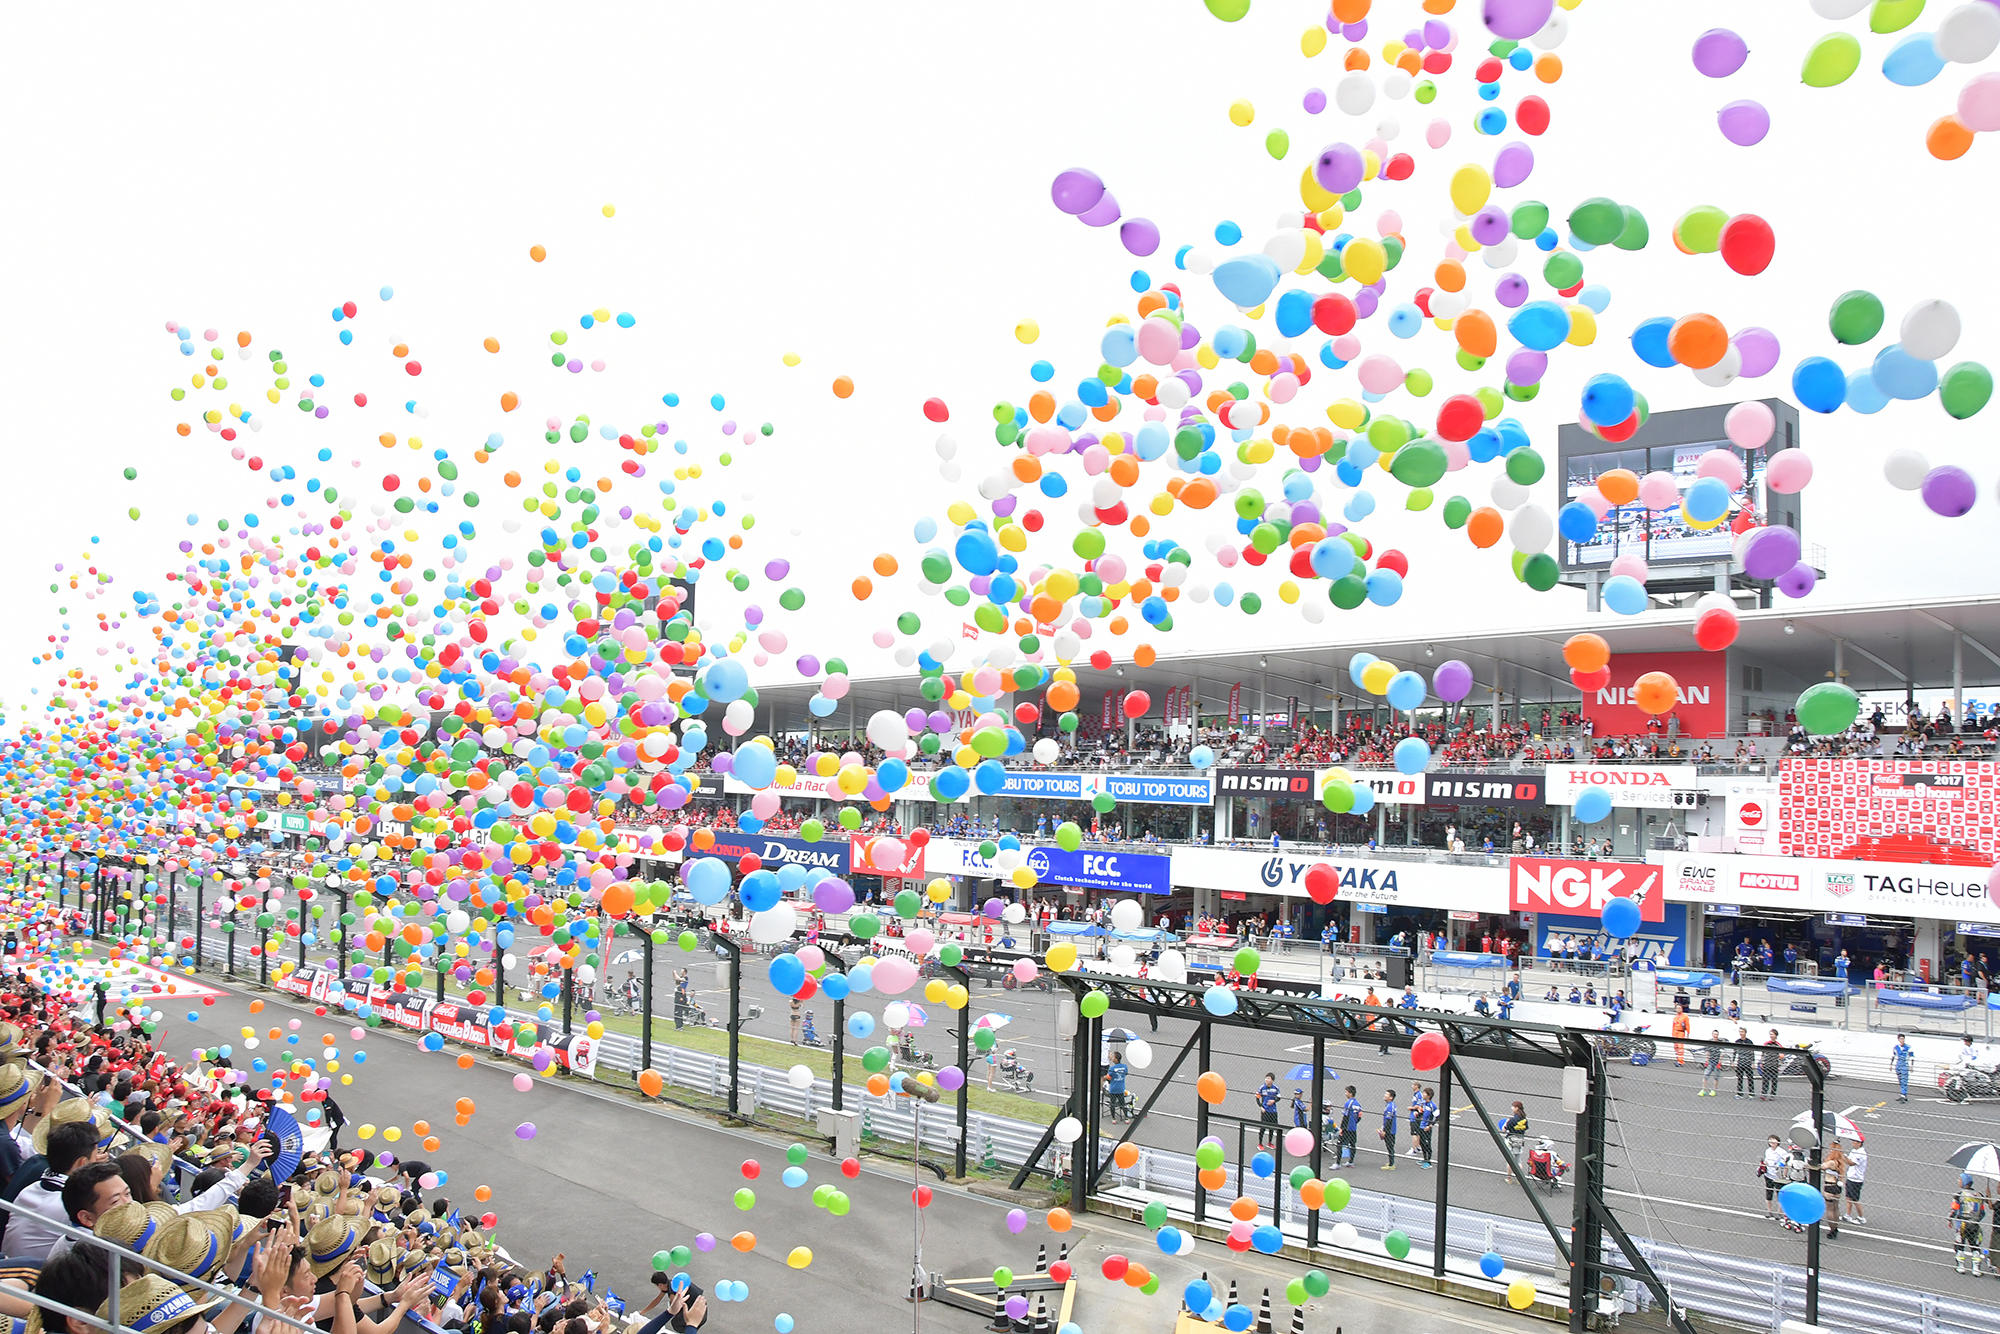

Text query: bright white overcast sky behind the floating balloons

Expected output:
[0,0,2000,714]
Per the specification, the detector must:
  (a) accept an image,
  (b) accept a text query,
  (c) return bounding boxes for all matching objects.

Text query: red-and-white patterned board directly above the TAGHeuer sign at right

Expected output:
[1778,758,2000,864]
